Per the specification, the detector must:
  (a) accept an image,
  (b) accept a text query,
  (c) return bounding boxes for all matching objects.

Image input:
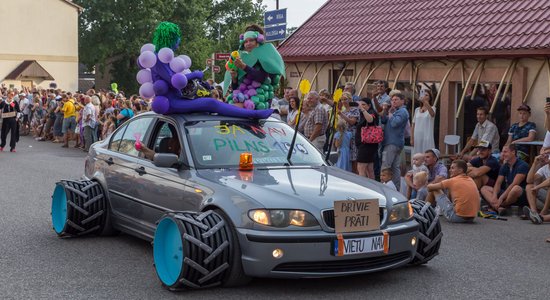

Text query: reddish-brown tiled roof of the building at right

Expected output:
[278,0,550,59]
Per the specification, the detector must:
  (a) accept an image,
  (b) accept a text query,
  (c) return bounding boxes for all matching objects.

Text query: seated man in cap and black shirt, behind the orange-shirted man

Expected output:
[468,140,500,189]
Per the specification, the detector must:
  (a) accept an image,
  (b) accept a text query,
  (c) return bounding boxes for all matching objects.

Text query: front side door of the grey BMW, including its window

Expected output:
[136,118,202,230]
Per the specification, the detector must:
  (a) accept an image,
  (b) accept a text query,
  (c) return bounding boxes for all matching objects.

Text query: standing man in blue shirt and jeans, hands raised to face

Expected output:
[381,93,409,191]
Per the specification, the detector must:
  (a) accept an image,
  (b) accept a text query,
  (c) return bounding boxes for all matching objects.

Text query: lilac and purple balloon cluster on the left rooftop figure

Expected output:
[136,44,191,105]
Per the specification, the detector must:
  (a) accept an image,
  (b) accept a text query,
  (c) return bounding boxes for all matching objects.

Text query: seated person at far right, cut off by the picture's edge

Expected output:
[523,154,550,224]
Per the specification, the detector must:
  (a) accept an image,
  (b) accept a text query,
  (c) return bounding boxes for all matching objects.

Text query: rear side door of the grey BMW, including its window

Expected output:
[101,116,154,222]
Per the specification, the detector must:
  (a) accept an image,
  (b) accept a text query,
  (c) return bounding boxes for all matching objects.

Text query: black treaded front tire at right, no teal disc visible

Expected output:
[411,200,443,265]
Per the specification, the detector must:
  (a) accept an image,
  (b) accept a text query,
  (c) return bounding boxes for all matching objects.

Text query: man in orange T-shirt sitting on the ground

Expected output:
[428,160,479,223]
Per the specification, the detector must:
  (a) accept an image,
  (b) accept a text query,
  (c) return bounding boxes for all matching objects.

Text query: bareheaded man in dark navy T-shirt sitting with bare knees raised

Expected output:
[481,144,529,214]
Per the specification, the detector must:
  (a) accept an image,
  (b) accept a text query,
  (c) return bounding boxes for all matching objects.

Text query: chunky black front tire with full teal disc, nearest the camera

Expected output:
[153,210,237,291]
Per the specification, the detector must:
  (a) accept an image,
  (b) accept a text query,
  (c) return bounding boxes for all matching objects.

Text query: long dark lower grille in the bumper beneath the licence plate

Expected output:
[273,252,411,273]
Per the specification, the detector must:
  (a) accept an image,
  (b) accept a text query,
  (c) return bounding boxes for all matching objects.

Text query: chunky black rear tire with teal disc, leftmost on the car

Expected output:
[52,180,108,237]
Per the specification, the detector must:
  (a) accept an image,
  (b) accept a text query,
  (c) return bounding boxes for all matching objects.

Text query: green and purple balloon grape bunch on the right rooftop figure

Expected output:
[227,75,280,110]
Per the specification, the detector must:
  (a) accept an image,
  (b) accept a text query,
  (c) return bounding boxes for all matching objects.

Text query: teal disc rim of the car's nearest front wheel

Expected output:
[153,218,183,286]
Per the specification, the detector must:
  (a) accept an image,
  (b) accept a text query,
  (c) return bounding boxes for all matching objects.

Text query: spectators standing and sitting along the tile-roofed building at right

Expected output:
[278,81,550,244]
